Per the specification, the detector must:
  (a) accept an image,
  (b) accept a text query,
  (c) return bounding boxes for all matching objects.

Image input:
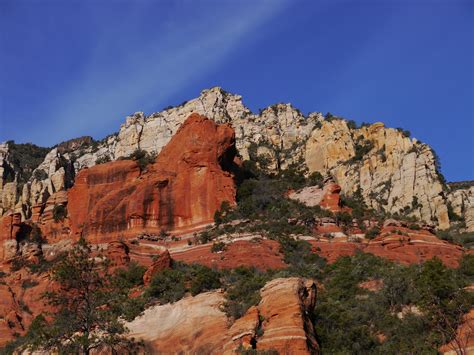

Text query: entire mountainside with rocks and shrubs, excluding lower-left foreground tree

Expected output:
[0,88,474,354]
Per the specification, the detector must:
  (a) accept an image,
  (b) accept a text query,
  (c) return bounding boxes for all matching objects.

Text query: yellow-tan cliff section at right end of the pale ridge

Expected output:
[305,119,449,229]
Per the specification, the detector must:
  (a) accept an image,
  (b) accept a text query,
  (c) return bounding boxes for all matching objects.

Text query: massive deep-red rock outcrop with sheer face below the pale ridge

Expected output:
[68,114,235,242]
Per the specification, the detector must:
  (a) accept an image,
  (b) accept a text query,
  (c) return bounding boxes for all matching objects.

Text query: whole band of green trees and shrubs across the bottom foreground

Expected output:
[2,235,474,354]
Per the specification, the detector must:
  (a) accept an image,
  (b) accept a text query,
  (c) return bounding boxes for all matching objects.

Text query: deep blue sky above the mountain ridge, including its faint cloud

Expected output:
[0,0,474,181]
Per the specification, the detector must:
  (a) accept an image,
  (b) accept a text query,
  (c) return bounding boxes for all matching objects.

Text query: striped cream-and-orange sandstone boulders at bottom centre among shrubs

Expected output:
[127,278,319,354]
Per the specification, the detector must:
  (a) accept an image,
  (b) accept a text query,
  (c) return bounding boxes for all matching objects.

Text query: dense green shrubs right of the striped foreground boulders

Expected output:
[314,253,474,354]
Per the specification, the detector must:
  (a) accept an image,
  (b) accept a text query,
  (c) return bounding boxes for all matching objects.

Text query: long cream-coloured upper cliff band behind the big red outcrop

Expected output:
[0,88,474,231]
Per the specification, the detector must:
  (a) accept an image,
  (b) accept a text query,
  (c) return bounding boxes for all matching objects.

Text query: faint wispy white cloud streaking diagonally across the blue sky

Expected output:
[50,0,286,142]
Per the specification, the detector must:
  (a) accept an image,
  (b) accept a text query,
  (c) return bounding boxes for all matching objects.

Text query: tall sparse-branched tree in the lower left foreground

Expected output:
[3,239,143,354]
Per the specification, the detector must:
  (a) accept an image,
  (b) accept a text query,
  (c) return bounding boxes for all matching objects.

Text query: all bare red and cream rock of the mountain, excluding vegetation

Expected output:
[0,88,473,353]
